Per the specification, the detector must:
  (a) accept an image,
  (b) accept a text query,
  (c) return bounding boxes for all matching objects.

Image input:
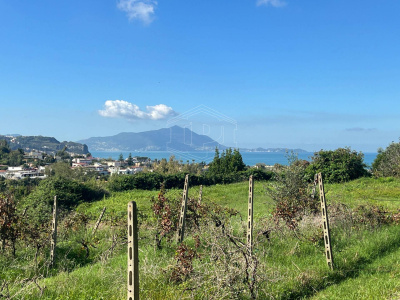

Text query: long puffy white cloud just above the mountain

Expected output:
[99,100,177,120]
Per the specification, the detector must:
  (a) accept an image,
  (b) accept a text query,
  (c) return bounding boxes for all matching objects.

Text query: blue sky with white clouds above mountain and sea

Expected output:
[0,0,400,152]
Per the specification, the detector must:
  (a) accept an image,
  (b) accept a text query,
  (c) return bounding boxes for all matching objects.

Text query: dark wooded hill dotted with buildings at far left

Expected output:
[0,135,89,154]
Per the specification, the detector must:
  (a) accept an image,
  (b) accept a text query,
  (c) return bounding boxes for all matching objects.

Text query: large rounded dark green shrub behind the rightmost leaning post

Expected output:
[306,148,368,183]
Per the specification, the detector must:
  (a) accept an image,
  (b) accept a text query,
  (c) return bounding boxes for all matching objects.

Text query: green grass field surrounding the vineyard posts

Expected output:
[0,178,400,299]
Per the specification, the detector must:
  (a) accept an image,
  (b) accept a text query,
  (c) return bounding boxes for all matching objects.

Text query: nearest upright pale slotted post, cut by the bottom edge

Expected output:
[128,201,139,300]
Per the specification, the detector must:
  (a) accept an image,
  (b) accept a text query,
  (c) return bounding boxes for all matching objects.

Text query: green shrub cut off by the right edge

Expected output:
[372,143,400,177]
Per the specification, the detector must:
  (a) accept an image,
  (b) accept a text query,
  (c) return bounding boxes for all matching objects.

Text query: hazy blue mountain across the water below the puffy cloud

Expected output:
[78,126,226,151]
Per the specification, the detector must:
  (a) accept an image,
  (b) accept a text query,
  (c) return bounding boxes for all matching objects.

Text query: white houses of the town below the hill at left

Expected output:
[0,151,151,179]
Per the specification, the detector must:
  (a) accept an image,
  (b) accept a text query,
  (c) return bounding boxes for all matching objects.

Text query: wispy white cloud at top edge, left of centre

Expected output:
[117,0,157,24]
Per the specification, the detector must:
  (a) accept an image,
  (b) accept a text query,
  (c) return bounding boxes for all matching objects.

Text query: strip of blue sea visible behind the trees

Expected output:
[91,151,378,167]
